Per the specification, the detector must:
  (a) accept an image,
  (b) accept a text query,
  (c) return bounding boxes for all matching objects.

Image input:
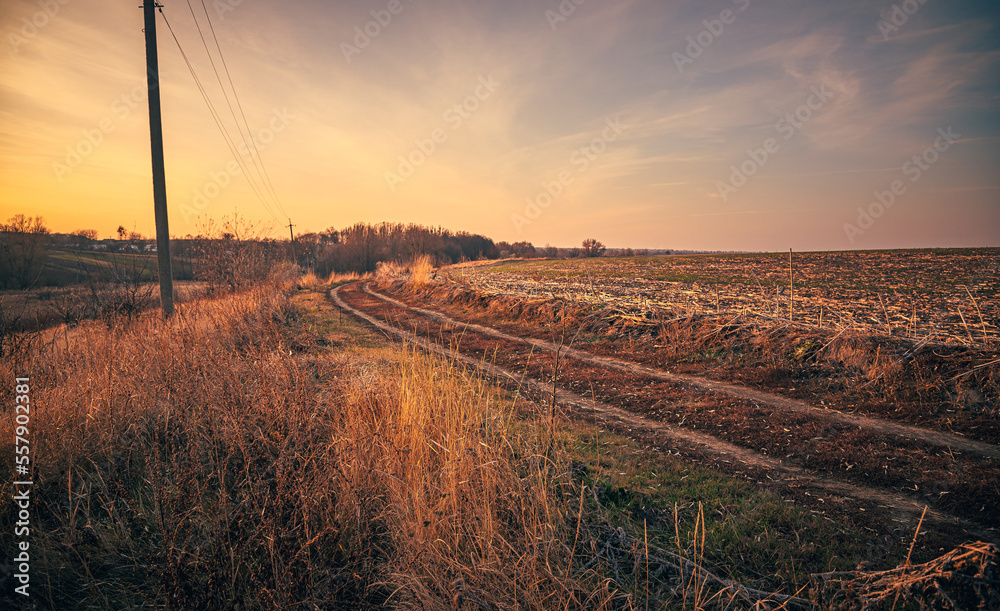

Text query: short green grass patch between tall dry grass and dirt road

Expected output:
[564,424,867,594]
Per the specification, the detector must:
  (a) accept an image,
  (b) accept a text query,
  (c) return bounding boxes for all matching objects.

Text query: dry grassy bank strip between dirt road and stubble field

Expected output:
[389,283,1000,444]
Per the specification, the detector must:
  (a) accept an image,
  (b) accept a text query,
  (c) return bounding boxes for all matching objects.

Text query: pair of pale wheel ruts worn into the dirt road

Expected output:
[331,284,1000,540]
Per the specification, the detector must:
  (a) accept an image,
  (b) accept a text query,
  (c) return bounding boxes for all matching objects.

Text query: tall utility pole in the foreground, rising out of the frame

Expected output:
[142,0,174,316]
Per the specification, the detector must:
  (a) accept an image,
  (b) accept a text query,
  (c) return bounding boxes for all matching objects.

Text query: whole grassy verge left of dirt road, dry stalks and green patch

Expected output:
[0,278,916,609]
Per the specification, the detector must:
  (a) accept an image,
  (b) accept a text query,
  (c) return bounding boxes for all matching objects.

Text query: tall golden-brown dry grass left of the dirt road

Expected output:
[0,286,614,609]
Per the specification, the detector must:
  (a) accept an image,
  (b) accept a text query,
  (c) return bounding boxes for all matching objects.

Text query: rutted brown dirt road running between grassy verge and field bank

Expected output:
[333,284,1000,568]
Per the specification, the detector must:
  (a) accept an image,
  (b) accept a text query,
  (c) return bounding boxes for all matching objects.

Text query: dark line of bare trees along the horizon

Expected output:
[0,214,647,289]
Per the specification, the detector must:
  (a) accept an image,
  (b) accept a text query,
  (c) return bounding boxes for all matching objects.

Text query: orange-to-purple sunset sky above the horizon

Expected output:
[0,0,1000,251]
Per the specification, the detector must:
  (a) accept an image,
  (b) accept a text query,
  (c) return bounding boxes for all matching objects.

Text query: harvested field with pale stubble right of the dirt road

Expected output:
[453,249,1000,348]
